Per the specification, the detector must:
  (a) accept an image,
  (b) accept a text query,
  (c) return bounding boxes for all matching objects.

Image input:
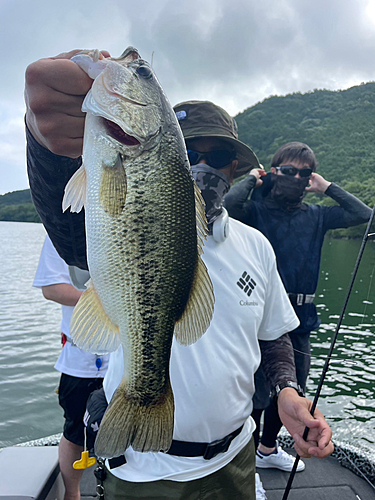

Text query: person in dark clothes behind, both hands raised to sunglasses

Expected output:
[225,142,371,471]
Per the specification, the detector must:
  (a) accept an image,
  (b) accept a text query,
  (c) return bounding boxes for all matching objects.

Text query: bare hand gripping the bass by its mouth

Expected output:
[25,50,109,158]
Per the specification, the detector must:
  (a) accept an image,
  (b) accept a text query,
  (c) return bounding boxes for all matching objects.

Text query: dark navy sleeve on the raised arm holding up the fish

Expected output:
[26,127,87,269]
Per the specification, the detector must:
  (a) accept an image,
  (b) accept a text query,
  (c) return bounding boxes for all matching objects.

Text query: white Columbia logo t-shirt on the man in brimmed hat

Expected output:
[104,219,299,482]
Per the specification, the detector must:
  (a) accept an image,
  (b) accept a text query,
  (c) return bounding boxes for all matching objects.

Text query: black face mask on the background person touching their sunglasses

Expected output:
[271,174,309,209]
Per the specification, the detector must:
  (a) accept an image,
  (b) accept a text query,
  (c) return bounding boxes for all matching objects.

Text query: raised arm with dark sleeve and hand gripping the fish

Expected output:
[25,50,109,269]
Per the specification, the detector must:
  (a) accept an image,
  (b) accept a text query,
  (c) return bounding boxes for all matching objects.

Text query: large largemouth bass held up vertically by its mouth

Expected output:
[63,47,214,458]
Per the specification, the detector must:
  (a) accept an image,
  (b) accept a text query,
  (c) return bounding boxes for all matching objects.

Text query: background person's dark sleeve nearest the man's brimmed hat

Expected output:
[224,175,257,224]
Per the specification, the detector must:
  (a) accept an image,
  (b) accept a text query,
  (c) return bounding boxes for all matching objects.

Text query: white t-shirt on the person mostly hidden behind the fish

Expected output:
[33,236,109,378]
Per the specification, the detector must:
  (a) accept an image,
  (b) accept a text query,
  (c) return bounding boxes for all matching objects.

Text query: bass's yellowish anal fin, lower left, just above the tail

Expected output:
[70,279,120,354]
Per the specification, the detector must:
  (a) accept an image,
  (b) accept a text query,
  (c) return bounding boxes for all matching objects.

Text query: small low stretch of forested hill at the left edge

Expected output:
[0,189,40,222]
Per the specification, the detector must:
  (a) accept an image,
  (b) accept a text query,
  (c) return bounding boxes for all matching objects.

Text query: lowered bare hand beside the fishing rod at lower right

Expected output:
[277,388,334,458]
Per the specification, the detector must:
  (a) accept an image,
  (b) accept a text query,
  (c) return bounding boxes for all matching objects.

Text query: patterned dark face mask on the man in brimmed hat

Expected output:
[191,163,230,224]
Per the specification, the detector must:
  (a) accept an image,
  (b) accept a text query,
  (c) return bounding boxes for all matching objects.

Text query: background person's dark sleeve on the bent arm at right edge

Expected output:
[325,183,371,229]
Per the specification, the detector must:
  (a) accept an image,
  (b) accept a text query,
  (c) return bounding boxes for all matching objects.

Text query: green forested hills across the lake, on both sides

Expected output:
[0,83,375,237]
